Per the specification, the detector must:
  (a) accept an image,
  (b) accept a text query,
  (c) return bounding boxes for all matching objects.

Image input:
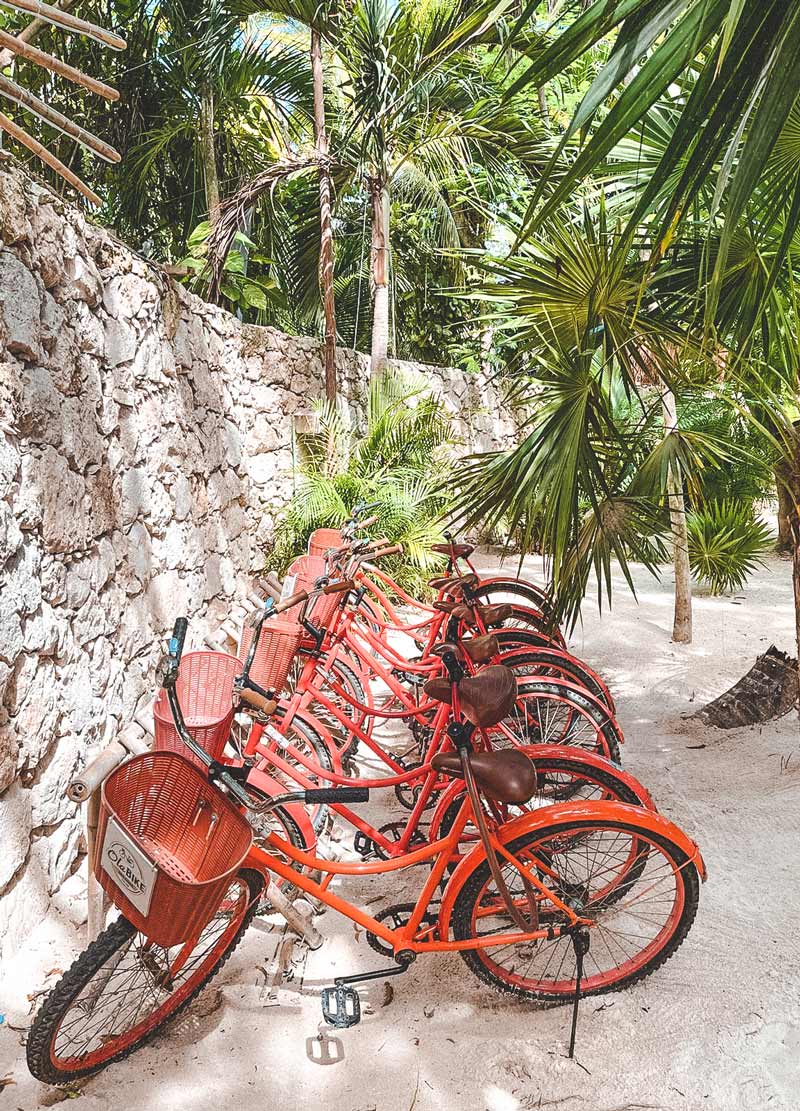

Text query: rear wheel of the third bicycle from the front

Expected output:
[483,679,623,763]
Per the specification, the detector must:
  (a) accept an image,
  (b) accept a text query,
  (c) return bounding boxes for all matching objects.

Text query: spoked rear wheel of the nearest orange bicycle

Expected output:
[452,818,699,1002]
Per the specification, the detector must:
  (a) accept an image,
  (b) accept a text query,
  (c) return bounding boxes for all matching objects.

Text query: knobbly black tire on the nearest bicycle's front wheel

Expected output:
[27,871,263,1084]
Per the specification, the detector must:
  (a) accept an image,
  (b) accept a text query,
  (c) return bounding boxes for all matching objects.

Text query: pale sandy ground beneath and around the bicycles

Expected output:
[0,558,800,1111]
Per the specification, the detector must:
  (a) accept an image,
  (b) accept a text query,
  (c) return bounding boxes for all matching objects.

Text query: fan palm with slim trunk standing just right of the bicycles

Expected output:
[460,211,742,641]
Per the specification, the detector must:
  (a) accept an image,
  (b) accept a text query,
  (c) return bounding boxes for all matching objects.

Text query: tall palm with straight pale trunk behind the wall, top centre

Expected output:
[213,0,542,376]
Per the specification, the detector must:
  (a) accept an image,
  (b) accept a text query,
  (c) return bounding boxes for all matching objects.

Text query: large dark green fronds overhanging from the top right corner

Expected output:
[512,0,800,311]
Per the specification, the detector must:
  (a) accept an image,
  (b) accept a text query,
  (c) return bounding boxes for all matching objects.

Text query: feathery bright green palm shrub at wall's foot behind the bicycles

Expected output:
[267,371,452,597]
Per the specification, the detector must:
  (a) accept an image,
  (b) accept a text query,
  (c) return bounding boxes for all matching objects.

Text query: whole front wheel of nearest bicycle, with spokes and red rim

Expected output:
[27,871,258,1084]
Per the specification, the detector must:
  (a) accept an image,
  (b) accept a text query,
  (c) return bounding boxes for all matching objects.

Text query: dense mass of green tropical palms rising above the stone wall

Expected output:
[3,0,800,657]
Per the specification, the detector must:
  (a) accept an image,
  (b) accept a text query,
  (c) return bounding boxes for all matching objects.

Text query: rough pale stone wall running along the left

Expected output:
[0,160,513,954]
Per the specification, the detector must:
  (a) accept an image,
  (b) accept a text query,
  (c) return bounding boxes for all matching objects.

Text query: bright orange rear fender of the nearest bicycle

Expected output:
[439,802,707,940]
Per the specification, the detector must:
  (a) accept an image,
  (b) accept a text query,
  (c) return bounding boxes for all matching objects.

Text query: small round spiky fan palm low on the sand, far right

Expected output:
[687,500,774,594]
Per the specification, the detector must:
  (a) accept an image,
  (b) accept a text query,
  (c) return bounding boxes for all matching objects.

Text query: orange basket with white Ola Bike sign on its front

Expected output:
[92,752,252,948]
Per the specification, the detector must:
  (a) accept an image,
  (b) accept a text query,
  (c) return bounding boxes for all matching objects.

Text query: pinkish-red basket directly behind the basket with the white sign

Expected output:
[153,652,241,767]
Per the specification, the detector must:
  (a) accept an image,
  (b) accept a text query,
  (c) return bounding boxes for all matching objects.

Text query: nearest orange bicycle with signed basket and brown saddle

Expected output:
[28,619,706,1083]
